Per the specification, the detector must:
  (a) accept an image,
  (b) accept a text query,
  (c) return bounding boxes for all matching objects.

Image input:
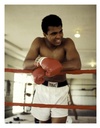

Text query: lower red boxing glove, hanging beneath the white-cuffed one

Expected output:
[32,67,45,84]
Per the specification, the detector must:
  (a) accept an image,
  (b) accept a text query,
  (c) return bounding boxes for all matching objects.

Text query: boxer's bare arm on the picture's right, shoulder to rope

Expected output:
[62,38,81,72]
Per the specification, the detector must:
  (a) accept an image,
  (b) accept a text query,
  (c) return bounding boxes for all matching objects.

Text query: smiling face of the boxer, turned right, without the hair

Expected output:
[45,26,63,46]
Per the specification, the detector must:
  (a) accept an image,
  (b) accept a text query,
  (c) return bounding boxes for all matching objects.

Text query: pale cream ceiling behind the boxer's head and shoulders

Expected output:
[5,5,96,69]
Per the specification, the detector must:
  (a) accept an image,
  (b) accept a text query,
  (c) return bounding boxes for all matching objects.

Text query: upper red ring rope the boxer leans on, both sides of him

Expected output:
[5,68,96,75]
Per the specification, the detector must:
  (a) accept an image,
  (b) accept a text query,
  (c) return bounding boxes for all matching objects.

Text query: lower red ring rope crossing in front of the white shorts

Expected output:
[5,102,96,110]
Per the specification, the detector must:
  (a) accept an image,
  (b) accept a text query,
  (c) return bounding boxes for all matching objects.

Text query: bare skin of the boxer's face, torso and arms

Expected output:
[24,26,81,82]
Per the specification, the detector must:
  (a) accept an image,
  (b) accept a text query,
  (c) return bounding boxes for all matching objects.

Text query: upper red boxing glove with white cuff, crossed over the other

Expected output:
[34,57,63,77]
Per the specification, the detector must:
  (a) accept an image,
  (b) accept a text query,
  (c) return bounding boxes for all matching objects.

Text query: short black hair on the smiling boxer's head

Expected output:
[41,14,62,34]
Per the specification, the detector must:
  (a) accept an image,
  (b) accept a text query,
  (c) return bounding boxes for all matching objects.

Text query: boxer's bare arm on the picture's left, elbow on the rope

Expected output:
[23,38,40,70]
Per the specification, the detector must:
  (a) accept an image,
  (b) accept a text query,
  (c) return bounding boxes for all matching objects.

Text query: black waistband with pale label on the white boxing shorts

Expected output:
[42,81,68,87]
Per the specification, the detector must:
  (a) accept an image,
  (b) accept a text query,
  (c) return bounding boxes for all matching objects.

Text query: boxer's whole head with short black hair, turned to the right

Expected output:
[41,14,63,46]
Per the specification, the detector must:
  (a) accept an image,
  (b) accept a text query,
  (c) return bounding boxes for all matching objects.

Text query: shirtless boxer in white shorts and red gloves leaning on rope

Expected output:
[24,14,81,123]
